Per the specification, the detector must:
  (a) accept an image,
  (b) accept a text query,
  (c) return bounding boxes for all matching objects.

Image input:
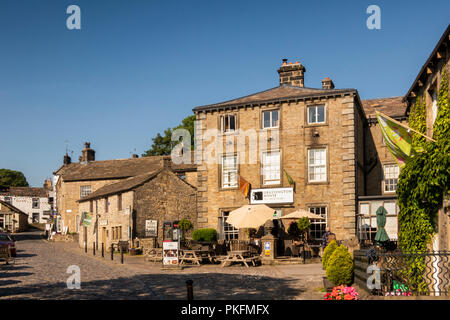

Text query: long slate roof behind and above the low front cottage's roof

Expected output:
[55,156,196,181]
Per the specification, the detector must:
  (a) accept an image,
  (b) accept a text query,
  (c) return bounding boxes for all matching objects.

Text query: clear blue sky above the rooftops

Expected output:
[0,0,450,186]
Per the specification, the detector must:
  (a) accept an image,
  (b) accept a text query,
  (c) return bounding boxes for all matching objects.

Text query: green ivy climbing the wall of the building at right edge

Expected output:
[397,70,450,292]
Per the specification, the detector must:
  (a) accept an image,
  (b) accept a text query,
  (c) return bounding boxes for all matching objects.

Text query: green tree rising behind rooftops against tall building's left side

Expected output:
[142,115,195,157]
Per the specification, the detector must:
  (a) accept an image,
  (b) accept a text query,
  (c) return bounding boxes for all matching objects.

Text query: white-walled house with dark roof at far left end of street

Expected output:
[0,185,53,223]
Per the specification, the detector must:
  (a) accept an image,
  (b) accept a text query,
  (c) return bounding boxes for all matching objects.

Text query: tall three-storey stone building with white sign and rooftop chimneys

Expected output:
[193,59,367,240]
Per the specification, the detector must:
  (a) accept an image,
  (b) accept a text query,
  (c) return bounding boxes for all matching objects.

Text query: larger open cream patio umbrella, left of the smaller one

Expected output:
[227,204,275,229]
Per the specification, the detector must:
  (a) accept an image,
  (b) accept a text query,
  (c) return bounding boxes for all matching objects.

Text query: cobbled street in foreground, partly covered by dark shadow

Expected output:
[0,232,323,300]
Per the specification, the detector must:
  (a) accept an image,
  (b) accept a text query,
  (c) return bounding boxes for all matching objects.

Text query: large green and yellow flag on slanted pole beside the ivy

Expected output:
[376,111,435,168]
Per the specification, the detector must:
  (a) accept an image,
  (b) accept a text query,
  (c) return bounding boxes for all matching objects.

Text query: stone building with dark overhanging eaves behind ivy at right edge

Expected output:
[403,25,450,250]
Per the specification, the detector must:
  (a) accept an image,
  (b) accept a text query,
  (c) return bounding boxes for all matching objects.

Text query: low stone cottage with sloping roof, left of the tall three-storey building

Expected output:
[78,168,197,248]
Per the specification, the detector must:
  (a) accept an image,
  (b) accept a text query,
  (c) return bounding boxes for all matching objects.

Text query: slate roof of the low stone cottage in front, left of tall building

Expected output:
[78,168,195,202]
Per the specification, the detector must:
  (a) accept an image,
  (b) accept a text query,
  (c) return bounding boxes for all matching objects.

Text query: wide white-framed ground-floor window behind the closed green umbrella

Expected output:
[357,200,398,241]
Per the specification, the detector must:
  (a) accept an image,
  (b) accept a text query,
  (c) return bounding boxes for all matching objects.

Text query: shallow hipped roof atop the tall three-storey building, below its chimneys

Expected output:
[193,85,357,112]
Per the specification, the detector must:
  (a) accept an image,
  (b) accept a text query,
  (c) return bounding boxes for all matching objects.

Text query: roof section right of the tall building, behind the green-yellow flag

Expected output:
[361,97,406,118]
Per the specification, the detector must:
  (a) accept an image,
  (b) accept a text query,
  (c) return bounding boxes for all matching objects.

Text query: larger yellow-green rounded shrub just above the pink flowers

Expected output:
[326,245,353,286]
